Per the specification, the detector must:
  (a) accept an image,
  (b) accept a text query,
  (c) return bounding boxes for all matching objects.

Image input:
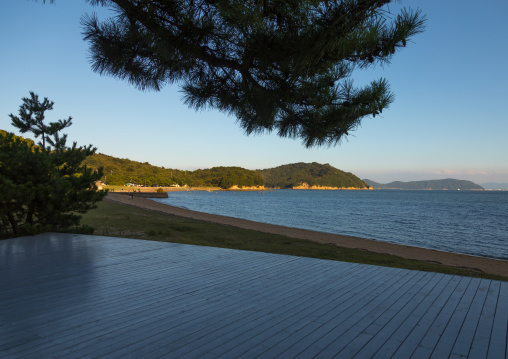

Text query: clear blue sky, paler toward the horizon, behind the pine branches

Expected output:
[0,0,508,183]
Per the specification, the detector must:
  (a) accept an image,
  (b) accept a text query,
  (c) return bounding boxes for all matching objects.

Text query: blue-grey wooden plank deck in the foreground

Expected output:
[0,234,508,358]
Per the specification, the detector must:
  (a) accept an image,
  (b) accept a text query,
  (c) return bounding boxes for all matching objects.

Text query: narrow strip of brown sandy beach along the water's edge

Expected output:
[106,193,508,277]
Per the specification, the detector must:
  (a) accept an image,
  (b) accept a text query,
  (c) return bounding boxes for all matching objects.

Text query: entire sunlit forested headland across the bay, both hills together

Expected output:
[85,154,371,189]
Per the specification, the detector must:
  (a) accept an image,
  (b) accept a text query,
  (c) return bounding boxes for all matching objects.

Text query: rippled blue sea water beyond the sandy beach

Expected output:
[152,190,508,260]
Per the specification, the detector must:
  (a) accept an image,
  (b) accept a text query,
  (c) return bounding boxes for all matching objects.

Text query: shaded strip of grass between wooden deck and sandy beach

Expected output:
[81,201,508,281]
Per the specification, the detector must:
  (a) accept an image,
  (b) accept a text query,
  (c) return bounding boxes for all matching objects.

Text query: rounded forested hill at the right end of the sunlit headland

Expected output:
[257,162,368,188]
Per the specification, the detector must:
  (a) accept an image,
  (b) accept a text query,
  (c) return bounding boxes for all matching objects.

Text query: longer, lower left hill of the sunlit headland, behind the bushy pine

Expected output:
[85,154,264,188]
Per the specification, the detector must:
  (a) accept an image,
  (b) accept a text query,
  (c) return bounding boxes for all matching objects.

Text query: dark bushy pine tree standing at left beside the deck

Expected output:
[0,93,106,238]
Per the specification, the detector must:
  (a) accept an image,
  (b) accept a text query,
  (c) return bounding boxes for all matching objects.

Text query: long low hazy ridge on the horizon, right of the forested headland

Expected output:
[364,178,484,191]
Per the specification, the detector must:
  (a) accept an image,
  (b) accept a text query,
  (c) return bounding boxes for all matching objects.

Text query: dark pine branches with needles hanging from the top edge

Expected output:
[82,0,425,147]
